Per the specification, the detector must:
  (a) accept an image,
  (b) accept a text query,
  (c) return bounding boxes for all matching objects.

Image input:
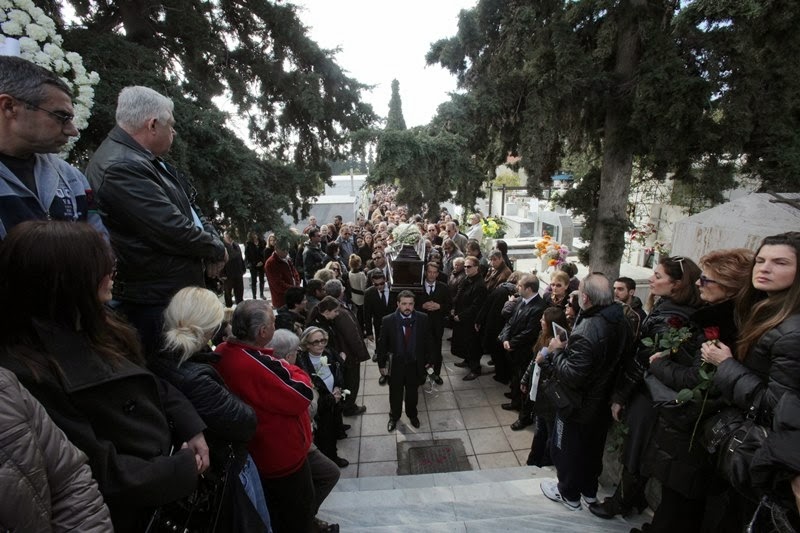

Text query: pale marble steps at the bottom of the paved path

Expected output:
[318,466,650,533]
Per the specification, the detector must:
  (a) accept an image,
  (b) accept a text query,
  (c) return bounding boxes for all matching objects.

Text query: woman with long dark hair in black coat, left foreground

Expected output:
[0,221,209,532]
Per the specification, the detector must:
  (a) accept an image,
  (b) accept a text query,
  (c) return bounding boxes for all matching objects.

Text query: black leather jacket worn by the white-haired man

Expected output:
[86,127,225,305]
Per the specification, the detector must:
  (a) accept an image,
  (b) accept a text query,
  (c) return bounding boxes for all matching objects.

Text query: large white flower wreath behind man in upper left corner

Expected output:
[0,0,100,155]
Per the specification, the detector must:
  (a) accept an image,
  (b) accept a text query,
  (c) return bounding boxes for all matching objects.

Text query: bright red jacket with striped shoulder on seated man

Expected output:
[216,340,313,478]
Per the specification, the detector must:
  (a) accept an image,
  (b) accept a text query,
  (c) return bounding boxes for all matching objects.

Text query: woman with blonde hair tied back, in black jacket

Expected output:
[150,287,270,531]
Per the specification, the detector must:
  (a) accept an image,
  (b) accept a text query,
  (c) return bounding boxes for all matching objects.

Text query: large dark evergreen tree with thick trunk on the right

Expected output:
[427,0,800,274]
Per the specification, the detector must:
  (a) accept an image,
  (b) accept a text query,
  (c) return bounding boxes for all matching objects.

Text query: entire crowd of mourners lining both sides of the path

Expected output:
[0,53,800,533]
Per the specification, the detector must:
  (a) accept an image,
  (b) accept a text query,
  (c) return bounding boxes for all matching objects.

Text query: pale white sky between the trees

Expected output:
[289,0,477,128]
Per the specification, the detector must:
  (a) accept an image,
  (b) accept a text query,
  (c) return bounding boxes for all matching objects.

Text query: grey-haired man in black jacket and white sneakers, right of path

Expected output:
[536,274,632,511]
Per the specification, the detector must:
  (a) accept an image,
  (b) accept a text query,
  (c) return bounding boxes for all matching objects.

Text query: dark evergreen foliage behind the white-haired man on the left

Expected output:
[43,0,375,237]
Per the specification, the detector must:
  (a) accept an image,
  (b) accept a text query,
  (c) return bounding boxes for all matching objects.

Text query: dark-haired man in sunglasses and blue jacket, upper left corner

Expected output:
[0,56,106,239]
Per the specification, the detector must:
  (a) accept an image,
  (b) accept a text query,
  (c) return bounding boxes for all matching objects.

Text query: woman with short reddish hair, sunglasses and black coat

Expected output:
[643,248,753,532]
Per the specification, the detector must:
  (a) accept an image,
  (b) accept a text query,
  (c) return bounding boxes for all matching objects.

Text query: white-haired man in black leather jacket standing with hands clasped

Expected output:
[86,86,227,355]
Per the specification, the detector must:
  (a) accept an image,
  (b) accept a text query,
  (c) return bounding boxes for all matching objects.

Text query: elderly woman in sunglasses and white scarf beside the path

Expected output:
[297,326,350,468]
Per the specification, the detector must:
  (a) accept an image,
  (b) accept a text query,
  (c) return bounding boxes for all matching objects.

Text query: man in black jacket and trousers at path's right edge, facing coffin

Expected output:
[497,275,547,431]
